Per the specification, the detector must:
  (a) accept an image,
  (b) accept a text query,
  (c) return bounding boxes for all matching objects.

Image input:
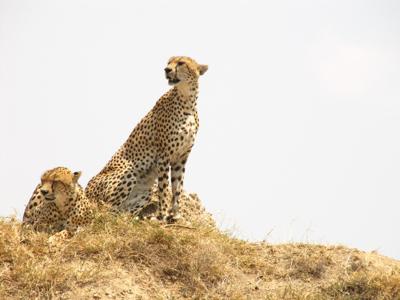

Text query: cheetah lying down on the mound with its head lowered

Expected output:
[23,167,92,238]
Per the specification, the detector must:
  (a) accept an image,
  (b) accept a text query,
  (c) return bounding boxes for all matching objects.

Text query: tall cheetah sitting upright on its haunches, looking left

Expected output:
[86,56,208,221]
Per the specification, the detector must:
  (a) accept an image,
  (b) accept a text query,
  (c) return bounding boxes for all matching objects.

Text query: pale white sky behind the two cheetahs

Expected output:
[0,0,400,258]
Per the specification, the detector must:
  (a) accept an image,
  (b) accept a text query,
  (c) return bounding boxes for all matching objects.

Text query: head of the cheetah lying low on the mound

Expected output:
[40,167,81,206]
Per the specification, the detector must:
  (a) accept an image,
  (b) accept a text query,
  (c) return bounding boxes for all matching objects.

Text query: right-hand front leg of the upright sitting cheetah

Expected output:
[170,153,189,220]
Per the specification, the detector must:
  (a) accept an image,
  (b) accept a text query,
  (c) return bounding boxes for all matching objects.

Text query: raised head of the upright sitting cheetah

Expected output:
[164,56,208,85]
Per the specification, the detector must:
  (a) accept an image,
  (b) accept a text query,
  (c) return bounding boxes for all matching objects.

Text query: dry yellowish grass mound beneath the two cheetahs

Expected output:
[0,212,400,299]
